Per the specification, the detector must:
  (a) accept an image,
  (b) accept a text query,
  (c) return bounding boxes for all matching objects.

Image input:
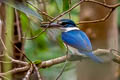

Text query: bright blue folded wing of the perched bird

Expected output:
[62,30,92,51]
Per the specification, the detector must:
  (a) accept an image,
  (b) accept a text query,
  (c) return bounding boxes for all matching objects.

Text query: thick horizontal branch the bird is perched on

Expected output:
[0,49,120,77]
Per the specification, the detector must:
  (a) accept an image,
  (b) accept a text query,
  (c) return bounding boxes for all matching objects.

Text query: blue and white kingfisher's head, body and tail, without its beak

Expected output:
[57,19,103,63]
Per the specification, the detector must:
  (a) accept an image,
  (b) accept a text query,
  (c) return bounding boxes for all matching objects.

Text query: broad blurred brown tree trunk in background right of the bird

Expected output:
[77,0,118,80]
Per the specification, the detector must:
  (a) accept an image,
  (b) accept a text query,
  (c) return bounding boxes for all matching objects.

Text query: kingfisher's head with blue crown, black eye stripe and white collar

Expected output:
[57,19,79,31]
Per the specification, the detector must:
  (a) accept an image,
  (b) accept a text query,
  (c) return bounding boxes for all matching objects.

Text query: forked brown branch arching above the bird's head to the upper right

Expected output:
[38,0,120,24]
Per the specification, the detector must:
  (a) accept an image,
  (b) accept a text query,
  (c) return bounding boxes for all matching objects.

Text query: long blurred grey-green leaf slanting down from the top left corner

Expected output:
[2,0,43,21]
